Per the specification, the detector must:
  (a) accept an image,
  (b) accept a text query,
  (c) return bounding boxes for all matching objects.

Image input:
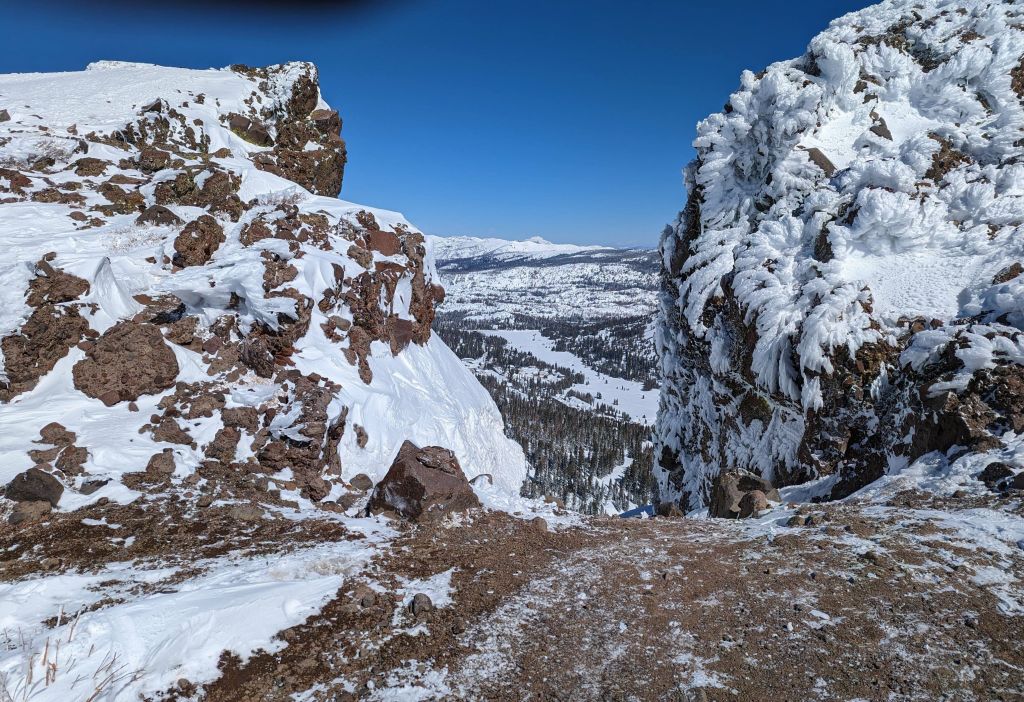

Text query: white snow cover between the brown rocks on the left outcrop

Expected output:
[0,61,525,497]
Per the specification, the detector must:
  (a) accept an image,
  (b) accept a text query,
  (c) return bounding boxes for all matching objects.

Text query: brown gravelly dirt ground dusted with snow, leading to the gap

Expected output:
[188,493,1024,702]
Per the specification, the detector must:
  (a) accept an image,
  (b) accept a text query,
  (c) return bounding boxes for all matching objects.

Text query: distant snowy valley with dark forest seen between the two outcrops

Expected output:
[429,236,658,514]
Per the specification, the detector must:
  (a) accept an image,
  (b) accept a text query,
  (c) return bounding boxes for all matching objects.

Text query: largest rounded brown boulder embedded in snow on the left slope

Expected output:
[72,321,178,406]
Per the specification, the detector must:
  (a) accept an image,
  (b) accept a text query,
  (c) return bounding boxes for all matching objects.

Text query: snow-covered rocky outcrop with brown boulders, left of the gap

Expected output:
[0,61,525,509]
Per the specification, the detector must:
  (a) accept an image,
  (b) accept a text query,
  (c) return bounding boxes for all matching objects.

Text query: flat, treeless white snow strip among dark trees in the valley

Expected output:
[479,330,658,425]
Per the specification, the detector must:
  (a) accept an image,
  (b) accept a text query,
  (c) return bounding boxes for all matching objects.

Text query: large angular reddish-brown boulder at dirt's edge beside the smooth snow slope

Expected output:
[369,441,480,521]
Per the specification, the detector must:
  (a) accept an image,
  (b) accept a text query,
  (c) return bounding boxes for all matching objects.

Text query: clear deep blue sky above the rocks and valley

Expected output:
[0,0,868,246]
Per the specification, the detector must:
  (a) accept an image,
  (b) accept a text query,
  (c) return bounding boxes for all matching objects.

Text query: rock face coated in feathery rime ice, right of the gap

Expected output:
[655,1,1024,508]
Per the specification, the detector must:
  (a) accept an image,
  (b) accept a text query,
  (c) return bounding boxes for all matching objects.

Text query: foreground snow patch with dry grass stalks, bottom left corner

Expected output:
[0,520,395,702]
